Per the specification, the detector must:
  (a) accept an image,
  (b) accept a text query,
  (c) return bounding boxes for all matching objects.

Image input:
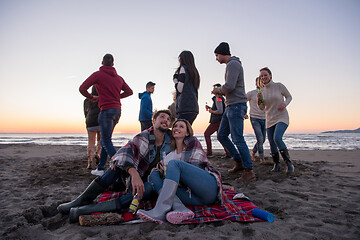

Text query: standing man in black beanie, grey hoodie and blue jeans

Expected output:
[212,42,256,182]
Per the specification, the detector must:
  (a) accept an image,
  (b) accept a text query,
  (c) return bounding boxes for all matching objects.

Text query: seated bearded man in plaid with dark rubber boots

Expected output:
[57,110,171,222]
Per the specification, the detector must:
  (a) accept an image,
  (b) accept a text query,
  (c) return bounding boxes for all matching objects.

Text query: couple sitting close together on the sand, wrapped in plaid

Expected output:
[57,110,222,224]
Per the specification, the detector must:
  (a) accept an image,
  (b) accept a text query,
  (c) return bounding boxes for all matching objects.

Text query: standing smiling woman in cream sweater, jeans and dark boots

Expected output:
[258,67,294,173]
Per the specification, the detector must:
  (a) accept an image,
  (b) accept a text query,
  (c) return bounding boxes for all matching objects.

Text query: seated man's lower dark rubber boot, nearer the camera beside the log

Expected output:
[69,198,121,223]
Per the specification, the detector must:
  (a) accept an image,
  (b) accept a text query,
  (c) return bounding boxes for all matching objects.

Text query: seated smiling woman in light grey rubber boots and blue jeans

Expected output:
[137,119,222,224]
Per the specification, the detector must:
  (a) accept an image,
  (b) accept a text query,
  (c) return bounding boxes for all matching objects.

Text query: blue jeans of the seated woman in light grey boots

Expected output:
[149,160,218,206]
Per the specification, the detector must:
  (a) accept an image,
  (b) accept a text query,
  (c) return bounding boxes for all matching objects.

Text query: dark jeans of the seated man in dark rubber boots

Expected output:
[99,168,155,208]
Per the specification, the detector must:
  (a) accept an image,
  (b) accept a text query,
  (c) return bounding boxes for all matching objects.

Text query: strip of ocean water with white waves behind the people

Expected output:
[0,133,360,150]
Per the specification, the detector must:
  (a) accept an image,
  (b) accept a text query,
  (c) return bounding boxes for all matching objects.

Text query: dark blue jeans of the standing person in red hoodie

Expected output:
[97,108,121,170]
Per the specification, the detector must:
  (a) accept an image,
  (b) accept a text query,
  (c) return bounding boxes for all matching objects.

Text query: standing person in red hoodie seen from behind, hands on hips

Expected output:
[79,54,133,176]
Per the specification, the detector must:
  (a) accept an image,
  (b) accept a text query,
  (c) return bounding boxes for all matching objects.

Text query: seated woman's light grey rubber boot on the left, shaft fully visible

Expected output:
[136,179,178,224]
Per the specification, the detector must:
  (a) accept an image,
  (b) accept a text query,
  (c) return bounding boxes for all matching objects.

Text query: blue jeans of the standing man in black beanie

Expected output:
[218,103,253,169]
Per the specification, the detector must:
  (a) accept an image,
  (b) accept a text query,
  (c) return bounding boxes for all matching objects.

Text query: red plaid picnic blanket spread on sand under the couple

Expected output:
[99,190,263,224]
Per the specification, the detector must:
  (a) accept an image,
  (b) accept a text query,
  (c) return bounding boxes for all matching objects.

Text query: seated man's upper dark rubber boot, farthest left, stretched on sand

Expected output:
[57,178,105,214]
